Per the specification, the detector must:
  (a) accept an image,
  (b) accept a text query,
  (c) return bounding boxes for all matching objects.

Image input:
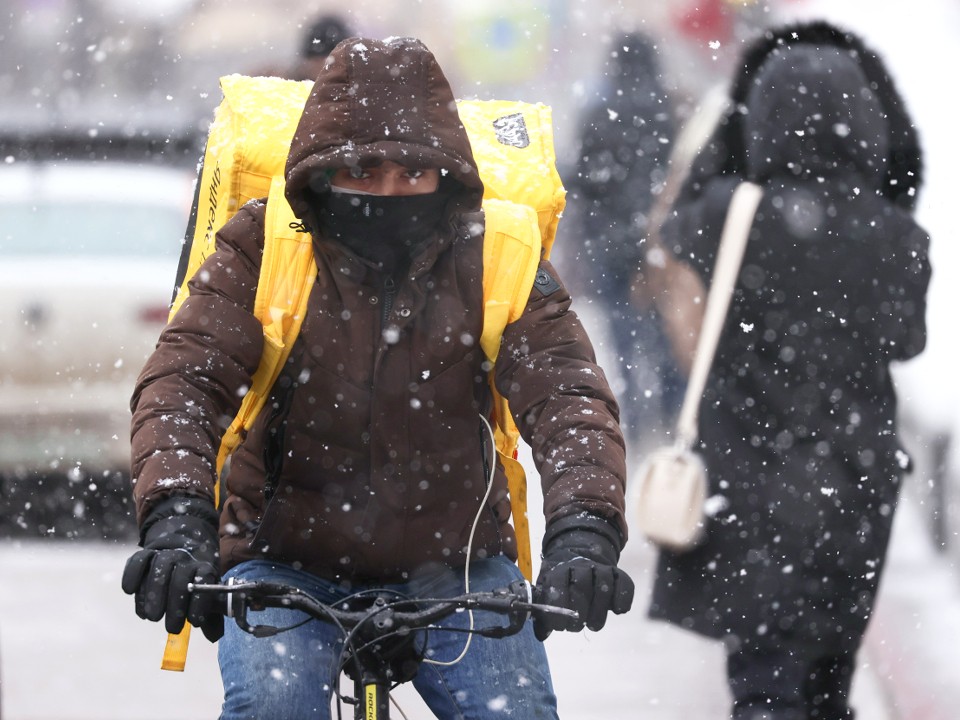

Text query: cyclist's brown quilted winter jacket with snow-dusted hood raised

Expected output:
[132,39,626,580]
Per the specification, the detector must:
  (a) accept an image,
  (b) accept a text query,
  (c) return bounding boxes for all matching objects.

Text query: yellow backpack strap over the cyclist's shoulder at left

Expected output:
[217,177,317,490]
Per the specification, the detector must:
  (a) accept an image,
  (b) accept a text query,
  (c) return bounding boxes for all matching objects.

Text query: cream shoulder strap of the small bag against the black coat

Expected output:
[676,182,763,448]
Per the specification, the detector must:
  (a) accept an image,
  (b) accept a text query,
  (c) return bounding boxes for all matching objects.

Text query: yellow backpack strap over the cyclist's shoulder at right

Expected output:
[480,198,541,581]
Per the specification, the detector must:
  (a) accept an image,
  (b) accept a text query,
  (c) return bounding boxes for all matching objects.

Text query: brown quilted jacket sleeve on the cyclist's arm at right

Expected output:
[496,261,627,538]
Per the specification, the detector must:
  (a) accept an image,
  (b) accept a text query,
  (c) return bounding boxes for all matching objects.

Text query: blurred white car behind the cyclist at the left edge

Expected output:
[0,158,194,528]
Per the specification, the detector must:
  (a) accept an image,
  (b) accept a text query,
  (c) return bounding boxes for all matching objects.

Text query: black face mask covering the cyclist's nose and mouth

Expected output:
[315,188,450,273]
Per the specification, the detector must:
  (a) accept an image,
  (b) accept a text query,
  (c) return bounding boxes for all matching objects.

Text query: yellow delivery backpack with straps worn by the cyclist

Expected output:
[162,75,566,670]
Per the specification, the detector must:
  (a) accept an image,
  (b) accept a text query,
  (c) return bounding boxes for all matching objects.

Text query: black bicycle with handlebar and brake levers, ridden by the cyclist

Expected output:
[189,579,577,720]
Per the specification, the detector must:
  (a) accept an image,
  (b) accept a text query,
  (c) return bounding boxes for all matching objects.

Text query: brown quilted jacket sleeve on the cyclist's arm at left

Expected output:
[131,204,263,522]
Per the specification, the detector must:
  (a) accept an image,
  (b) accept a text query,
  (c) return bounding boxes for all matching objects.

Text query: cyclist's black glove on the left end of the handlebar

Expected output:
[121,497,223,642]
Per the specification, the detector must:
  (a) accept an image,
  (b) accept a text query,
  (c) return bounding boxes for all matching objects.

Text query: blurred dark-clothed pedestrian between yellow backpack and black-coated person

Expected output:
[568,32,683,456]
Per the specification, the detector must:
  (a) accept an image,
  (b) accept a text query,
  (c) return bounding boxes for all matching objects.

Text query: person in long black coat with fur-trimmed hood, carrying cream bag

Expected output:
[649,22,930,720]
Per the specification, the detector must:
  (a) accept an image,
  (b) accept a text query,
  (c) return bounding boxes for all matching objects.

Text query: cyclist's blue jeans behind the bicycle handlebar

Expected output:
[218,556,557,720]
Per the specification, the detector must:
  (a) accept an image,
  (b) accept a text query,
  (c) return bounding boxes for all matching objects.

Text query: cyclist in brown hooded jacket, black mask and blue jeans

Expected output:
[123,38,633,719]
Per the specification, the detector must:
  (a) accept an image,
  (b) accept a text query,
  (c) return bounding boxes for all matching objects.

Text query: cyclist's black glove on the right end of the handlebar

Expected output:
[533,515,633,641]
